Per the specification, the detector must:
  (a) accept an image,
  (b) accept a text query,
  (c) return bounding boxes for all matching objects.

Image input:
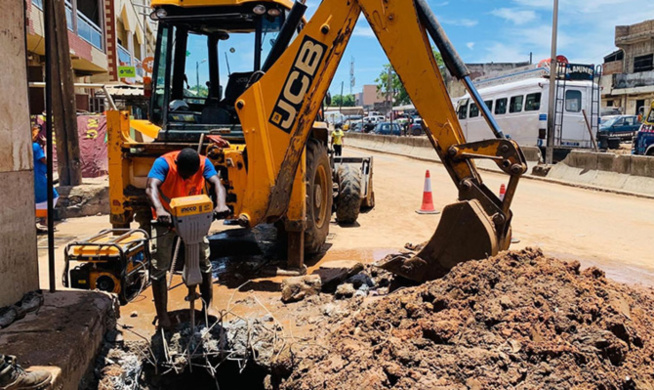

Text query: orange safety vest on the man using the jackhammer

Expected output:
[152,151,207,218]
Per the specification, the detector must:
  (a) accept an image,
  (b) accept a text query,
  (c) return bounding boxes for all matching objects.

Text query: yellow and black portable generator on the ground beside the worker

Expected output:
[63,229,150,304]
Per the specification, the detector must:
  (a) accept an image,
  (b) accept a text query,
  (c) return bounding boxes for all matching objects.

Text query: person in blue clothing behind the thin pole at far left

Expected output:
[32,124,59,232]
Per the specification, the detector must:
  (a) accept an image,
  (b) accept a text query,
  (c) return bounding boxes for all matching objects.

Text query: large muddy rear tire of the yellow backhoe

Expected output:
[304,139,333,254]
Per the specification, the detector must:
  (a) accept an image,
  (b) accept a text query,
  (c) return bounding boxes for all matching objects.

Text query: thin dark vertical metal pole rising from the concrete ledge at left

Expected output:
[43,0,55,293]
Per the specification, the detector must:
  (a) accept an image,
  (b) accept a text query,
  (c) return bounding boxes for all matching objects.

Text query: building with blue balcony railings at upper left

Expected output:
[25,0,156,114]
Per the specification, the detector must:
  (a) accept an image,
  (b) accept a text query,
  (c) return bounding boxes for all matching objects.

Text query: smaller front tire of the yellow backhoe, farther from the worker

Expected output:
[336,164,361,224]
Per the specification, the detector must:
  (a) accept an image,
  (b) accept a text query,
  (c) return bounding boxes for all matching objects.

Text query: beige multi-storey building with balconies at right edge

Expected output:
[602,20,654,115]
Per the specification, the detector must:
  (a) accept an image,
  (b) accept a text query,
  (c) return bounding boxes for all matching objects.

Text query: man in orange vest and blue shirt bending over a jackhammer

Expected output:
[146,148,230,329]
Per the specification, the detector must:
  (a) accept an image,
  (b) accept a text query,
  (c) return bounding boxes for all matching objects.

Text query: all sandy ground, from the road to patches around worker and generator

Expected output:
[39,148,654,338]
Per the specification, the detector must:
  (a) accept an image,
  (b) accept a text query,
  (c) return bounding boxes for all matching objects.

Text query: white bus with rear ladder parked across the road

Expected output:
[454,77,599,148]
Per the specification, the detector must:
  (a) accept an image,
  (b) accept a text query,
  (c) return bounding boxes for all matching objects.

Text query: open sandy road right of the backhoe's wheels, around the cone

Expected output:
[330,146,654,286]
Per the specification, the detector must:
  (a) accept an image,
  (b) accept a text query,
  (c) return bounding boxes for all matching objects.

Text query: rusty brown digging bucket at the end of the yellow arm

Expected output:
[377,200,500,282]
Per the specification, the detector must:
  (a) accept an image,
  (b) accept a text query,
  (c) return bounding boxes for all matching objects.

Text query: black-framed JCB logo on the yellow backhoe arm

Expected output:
[270,36,327,133]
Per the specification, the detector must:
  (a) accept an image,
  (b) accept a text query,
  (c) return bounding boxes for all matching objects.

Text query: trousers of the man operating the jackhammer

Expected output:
[151,226,211,280]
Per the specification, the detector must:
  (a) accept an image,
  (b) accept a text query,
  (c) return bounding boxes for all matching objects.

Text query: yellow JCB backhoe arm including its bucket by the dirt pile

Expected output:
[235,0,527,281]
